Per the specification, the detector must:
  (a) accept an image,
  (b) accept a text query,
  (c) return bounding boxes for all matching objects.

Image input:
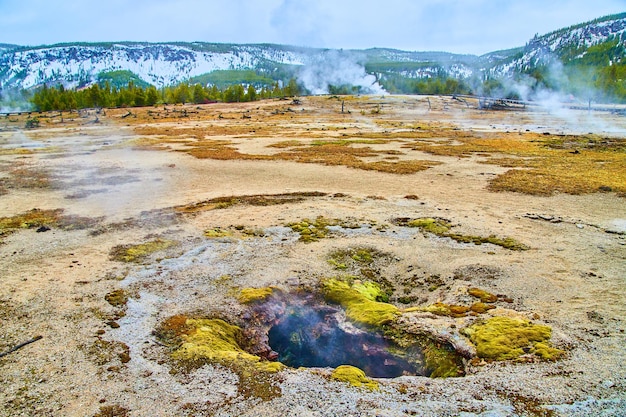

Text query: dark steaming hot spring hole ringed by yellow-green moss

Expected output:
[268,305,428,378]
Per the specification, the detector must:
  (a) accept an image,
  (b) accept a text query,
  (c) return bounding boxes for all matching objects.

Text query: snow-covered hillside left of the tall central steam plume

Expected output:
[0,43,307,88]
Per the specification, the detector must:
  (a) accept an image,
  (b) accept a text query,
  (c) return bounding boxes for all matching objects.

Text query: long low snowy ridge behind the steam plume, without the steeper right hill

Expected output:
[0,42,477,92]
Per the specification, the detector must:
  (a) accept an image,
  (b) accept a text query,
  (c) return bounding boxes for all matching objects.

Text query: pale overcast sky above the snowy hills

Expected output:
[0,0,626,55]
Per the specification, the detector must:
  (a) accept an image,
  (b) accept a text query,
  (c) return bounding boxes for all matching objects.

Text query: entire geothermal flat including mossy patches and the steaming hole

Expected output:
[0,96,626,417]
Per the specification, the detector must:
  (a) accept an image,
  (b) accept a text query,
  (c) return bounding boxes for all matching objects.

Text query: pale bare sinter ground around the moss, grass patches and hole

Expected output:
[0,96,626,416]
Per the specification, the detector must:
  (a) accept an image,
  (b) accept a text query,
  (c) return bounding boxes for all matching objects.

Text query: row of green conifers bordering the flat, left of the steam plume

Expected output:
[30,79,300,111]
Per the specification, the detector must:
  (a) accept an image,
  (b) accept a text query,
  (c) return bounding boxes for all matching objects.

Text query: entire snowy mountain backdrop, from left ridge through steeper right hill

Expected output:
[0,13,626,91]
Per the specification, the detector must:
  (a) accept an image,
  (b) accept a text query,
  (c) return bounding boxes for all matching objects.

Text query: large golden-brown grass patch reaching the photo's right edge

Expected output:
[404,133,626,196]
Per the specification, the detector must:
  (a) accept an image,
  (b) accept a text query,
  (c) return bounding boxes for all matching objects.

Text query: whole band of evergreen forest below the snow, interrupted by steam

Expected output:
[23,34,626,111]
